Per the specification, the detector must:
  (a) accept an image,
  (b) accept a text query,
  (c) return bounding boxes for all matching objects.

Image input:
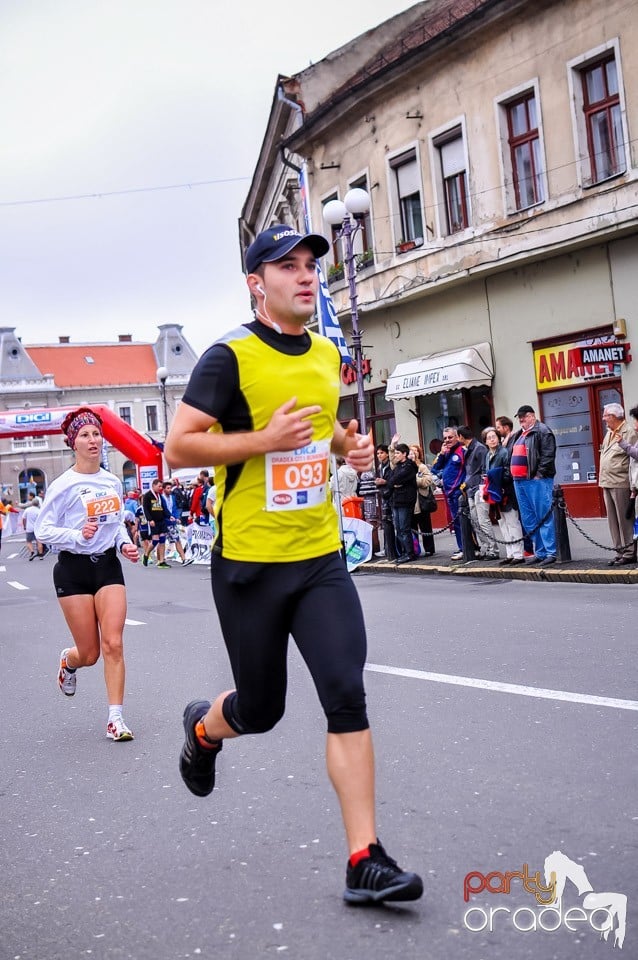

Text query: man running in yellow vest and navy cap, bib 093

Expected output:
[166,224,423,903]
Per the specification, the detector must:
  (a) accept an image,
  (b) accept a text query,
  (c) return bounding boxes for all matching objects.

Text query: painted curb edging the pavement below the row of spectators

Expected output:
[354,560,638,584]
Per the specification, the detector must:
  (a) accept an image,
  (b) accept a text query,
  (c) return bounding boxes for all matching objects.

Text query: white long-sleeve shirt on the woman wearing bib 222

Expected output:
[34,467,131,555]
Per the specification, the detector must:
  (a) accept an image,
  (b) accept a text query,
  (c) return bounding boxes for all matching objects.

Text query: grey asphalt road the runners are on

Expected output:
[0,543,638,960]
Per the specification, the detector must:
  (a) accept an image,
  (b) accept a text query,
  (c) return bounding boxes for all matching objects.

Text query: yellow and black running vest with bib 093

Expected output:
[213,327,341,563]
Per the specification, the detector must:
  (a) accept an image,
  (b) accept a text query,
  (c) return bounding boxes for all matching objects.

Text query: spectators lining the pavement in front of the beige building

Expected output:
[358,403,638,567]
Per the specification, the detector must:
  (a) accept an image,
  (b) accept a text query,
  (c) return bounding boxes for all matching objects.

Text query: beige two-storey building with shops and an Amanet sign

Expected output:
[240,0,638,516]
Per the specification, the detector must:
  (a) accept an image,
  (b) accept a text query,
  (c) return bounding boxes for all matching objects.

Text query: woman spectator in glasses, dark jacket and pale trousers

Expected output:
[484,427,524,565]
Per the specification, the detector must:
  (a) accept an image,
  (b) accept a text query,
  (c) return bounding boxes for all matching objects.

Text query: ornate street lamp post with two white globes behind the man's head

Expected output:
[323,187,370,433]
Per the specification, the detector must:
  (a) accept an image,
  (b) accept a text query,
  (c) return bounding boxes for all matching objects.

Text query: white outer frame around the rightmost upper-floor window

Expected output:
[567,37,631,189]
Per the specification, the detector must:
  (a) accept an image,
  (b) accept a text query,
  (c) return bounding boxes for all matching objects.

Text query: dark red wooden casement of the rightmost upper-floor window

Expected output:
[581,56,626,183]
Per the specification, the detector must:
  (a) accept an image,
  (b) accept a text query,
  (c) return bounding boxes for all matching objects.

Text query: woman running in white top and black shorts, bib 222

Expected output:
[35,407,138,740]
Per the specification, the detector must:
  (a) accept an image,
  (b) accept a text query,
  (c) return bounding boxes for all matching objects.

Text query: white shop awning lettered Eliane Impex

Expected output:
[385,343,494,400]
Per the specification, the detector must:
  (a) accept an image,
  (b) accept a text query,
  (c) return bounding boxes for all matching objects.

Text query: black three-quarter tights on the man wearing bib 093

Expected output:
[211,553,368,733]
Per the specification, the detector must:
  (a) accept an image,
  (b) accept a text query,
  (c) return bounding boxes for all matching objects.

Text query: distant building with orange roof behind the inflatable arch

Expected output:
[0,323,197,502]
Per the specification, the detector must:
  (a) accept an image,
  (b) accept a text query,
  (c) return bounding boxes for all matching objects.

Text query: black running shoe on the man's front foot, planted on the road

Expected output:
[343,841,423,903]
